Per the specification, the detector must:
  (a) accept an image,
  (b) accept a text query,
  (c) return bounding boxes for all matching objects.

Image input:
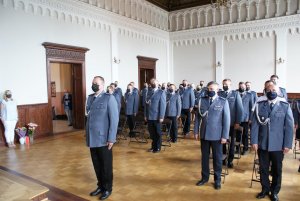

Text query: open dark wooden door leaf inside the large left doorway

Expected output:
[72,64,85,129]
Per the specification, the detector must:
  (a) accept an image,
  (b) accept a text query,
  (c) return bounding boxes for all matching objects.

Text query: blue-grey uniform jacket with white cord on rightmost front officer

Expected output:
[251,98,294,151]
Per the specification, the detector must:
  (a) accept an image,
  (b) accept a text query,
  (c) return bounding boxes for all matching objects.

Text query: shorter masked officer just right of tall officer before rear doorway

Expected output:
[166,84,181,143]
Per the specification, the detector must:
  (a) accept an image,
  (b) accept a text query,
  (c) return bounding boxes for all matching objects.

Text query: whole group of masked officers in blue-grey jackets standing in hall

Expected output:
[86,75,296,200]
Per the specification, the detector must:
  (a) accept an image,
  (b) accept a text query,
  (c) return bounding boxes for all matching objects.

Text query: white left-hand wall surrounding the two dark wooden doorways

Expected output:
[0,0,168,105]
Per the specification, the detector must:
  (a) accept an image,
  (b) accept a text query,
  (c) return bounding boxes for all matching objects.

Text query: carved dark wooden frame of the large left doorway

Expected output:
[42,42,89,133]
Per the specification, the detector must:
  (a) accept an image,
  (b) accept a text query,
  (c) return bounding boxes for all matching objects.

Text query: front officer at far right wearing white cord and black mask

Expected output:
[251,84,294,201]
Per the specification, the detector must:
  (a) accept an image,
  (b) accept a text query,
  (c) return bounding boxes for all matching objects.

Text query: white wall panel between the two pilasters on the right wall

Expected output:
[224,35,275,92]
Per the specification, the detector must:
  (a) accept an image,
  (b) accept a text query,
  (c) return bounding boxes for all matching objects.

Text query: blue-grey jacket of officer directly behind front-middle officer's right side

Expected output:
[218,90,243,126]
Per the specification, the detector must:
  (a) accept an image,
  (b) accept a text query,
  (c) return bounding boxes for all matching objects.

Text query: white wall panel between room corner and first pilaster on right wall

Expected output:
[173,42,215,85]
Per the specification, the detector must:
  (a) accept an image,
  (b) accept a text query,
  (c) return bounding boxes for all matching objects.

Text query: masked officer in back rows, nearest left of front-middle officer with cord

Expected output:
[181,80,195,137]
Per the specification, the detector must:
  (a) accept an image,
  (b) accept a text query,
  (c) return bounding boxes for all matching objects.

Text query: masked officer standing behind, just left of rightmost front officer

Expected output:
[236,82,253,155]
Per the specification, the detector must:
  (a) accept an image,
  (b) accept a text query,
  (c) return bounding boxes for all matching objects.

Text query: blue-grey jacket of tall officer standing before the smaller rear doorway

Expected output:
[144,88,166,120]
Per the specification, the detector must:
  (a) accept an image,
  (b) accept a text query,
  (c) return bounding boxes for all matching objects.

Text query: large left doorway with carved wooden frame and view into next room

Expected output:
[43,43,88,134]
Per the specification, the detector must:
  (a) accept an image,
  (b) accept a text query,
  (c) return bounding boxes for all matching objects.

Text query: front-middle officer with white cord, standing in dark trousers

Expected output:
[196,81,230,190]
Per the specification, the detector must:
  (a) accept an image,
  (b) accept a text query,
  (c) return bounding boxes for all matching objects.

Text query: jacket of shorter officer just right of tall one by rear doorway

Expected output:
[166,93,181,117]
